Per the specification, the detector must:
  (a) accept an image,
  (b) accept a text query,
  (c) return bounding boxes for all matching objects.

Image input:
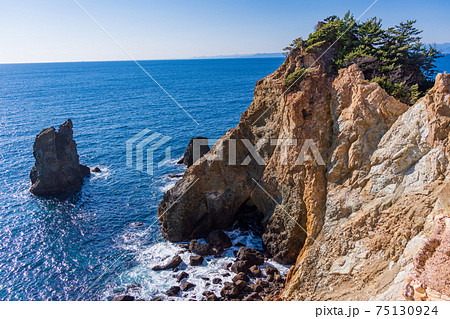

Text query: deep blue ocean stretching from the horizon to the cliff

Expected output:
[0,56,450,300]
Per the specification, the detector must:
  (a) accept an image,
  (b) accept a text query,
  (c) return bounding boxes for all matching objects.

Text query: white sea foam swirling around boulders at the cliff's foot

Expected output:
[103,230,289,300]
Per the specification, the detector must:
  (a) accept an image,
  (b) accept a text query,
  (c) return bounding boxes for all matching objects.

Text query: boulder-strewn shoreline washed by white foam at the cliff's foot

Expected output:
[109,231,287,301]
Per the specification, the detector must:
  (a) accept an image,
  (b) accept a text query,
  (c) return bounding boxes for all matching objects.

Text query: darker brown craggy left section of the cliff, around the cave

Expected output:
[158,47,332,263]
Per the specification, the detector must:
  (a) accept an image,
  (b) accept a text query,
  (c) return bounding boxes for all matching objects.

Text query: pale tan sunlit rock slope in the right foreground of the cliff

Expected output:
[281,71,450,300]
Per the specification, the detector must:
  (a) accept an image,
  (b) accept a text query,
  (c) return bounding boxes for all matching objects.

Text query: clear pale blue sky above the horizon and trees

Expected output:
[0,0,450,63]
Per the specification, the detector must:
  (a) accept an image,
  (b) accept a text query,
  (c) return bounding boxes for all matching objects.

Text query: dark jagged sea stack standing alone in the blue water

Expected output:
[30,119,90,196]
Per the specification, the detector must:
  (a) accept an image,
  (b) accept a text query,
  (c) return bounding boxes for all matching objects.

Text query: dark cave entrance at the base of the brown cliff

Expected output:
[233,199,264,236]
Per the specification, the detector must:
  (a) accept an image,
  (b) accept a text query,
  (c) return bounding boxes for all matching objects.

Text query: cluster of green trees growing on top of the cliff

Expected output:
[284,12,442,104]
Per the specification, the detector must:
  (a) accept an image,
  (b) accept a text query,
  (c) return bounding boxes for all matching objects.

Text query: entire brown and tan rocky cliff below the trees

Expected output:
[158,48,450,300]
